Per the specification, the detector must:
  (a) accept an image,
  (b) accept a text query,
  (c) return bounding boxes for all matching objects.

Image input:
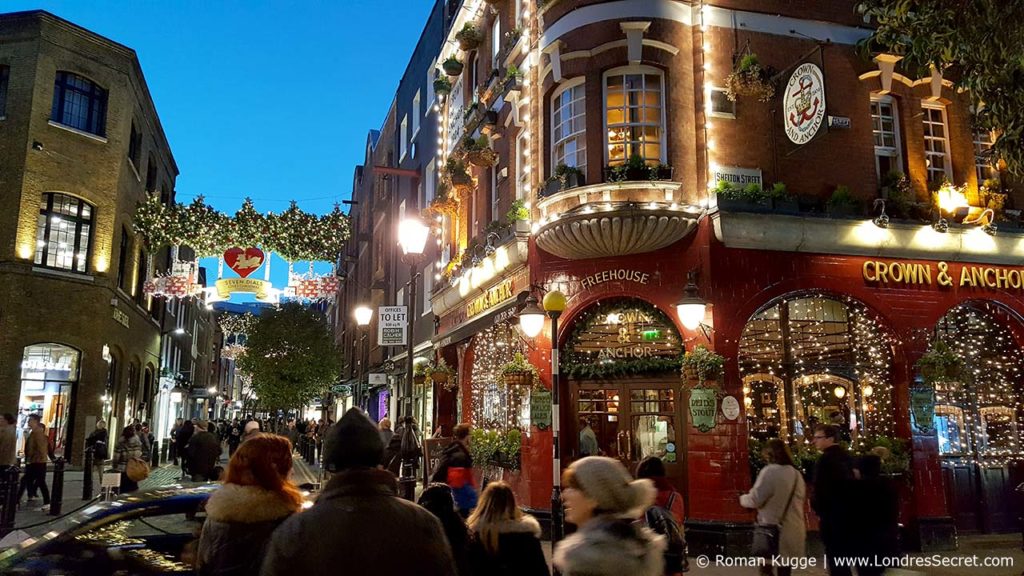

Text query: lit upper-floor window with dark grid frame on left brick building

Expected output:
[34,193,92,273]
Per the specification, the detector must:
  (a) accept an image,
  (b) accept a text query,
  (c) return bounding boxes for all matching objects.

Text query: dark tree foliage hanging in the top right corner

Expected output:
[859,0,1024,174]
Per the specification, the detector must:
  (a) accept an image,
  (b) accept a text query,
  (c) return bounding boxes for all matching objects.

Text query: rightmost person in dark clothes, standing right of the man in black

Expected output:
[854,454,899,576]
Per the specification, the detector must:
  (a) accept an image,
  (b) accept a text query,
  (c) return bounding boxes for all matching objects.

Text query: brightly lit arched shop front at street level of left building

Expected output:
[17,342,81,455]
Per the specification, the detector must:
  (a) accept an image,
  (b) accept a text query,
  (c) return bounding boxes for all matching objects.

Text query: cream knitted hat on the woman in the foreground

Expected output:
[569,456,657,518]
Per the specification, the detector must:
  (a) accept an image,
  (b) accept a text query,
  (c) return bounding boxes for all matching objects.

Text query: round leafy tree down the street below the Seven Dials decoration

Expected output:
[238,304,341,410]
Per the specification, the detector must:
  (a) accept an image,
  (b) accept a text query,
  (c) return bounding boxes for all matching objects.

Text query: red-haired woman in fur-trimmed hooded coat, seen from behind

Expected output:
[196,435,302,576]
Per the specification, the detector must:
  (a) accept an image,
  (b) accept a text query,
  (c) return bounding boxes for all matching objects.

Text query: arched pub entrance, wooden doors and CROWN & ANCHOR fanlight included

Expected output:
[559,298,685,477]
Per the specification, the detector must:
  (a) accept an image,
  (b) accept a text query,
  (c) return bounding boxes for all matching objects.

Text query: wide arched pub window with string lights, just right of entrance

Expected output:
[738,293,894,444]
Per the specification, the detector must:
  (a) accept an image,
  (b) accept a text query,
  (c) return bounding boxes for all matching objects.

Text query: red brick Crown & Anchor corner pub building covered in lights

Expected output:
[362,0,1024,550]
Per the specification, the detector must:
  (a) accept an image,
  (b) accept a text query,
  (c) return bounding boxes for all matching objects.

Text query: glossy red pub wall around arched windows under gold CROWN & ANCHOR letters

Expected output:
[708,226,1024,520]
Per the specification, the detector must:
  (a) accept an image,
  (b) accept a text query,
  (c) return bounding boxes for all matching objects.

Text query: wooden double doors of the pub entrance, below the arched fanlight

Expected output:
[562,378,686,495]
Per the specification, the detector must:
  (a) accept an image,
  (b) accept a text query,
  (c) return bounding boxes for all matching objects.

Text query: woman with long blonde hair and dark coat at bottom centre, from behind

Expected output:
[468,482,551,576]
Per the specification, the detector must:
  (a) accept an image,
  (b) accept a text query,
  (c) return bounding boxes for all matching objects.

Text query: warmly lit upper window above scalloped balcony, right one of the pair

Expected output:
[604,67,665,166]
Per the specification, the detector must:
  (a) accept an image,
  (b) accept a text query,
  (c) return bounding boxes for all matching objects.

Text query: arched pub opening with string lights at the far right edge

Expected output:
[918,302,1024,532]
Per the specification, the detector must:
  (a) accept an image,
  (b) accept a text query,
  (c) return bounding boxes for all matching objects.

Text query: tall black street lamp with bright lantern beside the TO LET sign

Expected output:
[398,218,430,500]
